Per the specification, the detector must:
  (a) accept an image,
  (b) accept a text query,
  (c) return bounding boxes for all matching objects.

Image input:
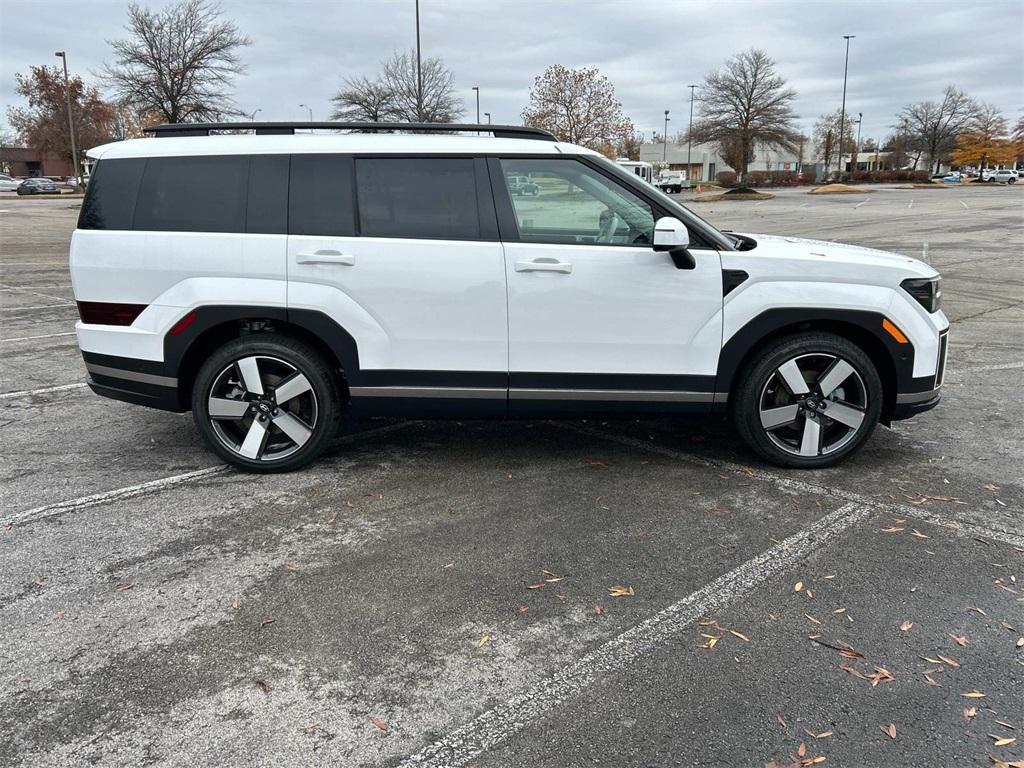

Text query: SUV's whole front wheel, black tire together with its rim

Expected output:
[730,331,883,469]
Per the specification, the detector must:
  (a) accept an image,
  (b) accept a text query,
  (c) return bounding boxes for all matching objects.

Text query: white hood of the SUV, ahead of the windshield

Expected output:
[736,232,938,278]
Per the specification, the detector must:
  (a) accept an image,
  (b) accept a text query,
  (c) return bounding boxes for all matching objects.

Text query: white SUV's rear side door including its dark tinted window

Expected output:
[288,155,508,415]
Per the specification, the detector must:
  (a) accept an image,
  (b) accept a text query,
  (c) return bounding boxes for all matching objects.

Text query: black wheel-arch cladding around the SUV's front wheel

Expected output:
[716,307,935,393]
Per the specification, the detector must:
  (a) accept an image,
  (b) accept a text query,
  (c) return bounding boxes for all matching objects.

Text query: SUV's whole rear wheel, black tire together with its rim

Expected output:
[191,333,343,473]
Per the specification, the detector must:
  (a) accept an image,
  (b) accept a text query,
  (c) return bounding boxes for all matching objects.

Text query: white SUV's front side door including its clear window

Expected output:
[492,158,722,413]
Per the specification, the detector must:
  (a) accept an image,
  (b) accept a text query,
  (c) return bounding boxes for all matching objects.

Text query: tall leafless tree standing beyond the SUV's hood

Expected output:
[692,48,800,180]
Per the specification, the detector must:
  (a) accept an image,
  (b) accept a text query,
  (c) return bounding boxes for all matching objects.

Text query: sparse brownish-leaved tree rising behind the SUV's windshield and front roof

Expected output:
[522,65,636,154]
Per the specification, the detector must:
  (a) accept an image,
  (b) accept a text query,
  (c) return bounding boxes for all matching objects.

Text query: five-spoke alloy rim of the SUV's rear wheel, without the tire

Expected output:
[207,355,318,462]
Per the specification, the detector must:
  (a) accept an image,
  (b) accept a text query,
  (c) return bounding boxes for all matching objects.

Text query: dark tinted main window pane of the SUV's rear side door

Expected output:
[355,158,481,240]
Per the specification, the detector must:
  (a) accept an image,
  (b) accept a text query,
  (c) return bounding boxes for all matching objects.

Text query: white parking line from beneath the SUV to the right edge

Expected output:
[561,422,1024,547]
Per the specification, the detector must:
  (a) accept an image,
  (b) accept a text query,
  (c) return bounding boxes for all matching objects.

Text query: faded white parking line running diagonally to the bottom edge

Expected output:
[403,504,871,768]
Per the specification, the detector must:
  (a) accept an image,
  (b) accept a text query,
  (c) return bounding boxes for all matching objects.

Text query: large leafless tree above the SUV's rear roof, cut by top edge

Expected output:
[103,0,251,123]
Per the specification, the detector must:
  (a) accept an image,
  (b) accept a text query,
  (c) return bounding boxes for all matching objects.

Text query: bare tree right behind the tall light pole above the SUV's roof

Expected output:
[380,51,465,123]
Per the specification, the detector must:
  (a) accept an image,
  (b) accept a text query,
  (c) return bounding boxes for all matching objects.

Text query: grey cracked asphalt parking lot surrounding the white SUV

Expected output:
[0,185,1024,768]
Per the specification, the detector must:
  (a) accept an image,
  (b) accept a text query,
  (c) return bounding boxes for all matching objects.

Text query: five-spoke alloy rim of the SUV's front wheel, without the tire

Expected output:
[758,353,868,458]
